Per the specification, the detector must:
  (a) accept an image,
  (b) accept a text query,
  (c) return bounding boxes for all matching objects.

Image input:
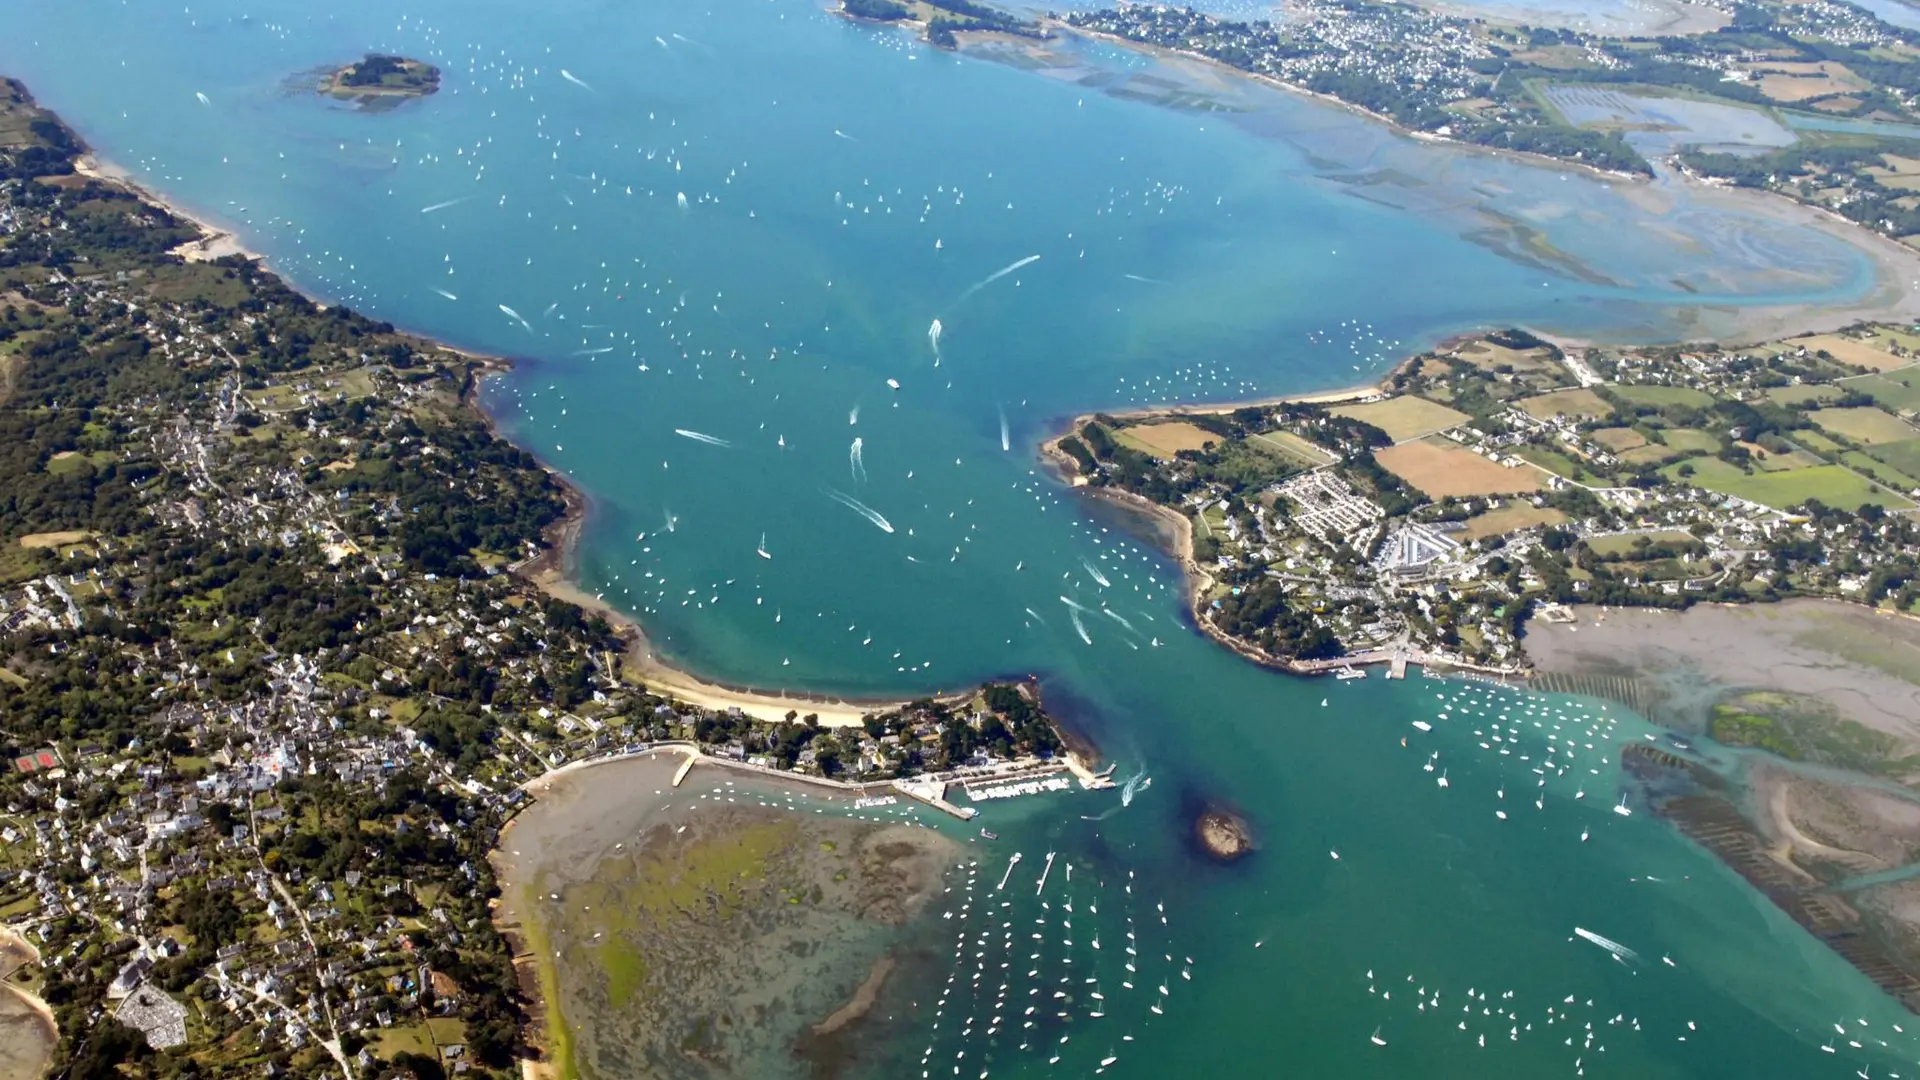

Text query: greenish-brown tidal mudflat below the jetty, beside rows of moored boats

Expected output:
[495,753,960,1078]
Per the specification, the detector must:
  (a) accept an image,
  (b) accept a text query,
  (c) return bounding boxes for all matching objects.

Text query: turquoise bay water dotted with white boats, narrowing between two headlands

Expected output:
[11,0,1916,1078]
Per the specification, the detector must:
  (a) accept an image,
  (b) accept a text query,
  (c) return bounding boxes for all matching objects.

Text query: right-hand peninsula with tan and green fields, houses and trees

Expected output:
[1050,327,1920,675]
